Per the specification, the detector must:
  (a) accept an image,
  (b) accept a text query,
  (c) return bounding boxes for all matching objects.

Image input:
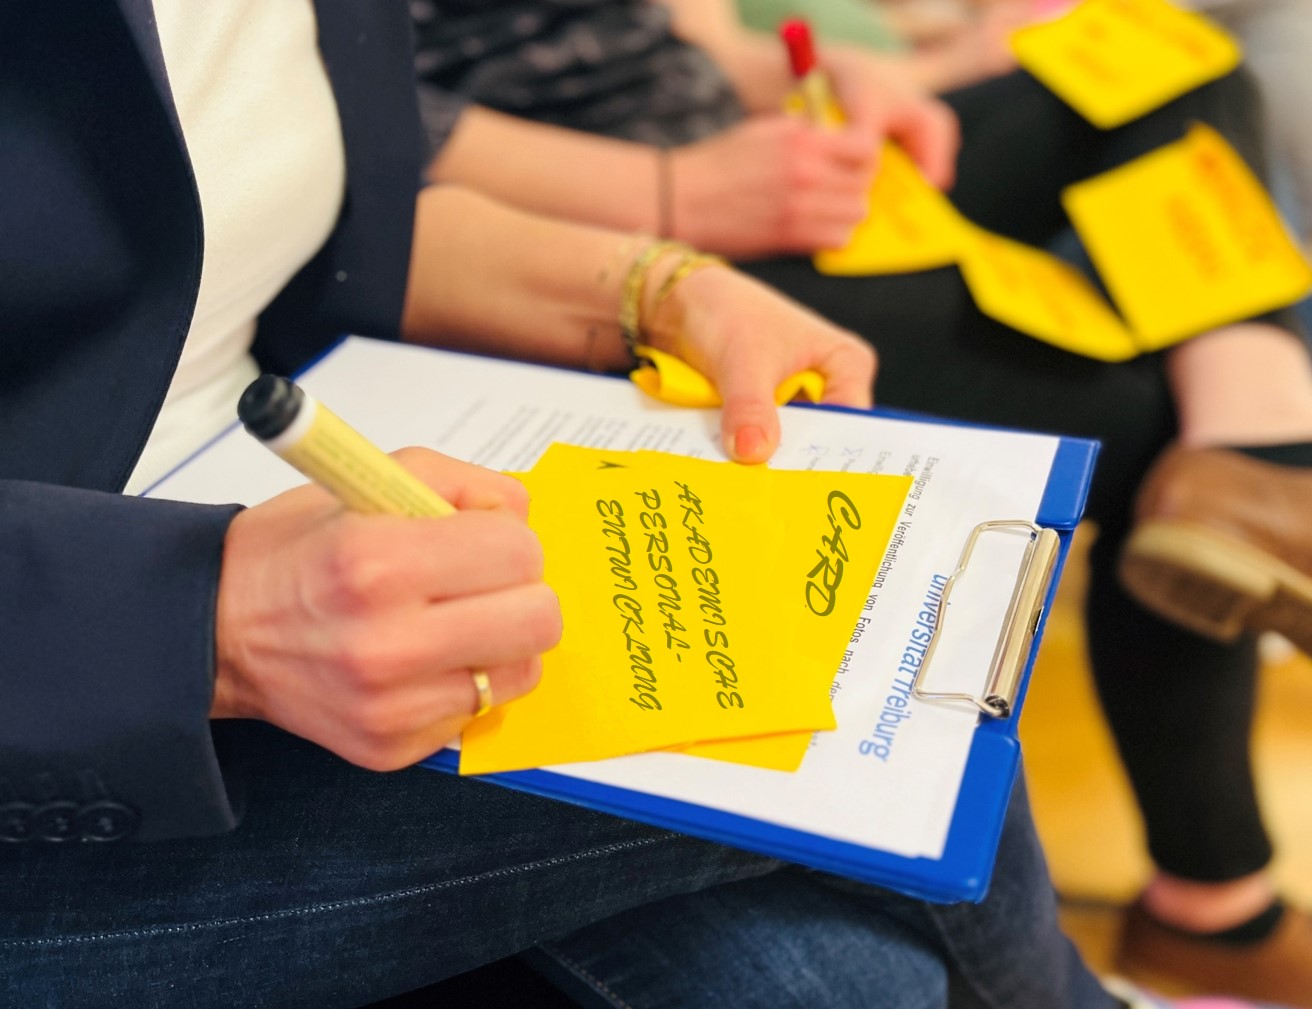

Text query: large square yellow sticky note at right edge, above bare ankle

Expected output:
[1063,125,1312,350]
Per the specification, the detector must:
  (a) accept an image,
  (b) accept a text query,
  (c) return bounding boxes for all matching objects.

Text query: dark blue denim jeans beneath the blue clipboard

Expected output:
[0,723,1115,1009]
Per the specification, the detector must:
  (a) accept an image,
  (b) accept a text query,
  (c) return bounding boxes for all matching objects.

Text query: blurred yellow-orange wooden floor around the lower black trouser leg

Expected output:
[1021,530,1312,971]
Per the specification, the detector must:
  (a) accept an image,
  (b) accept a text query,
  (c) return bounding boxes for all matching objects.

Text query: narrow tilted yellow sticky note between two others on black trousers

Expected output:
[962,228,1140,361]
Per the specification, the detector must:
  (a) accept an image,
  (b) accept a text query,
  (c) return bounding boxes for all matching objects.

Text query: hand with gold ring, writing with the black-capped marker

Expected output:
[211,449,560,770]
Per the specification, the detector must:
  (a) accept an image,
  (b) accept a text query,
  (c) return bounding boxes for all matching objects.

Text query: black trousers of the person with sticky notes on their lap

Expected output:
[744,73,1295,882]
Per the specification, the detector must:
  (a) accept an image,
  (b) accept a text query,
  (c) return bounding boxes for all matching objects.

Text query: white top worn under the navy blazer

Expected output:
[126,0,346,493]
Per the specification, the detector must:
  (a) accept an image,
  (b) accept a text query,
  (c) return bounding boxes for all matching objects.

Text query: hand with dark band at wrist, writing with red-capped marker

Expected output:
[668,114,879,258]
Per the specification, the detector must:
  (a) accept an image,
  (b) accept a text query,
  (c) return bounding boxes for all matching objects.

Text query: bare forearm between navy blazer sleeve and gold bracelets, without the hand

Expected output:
[401,185,640,370]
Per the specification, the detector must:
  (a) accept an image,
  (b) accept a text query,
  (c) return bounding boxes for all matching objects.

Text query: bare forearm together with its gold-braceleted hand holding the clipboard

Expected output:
[401,186,874,463]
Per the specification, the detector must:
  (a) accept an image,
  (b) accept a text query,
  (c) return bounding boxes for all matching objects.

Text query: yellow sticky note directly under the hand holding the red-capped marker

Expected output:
[813,143,966,276]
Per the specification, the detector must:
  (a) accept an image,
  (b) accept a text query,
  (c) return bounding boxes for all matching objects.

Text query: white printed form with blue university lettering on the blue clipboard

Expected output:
[148,339,1057,858]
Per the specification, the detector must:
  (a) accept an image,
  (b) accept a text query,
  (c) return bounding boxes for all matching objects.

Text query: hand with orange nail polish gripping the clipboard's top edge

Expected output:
[644,268,875,463]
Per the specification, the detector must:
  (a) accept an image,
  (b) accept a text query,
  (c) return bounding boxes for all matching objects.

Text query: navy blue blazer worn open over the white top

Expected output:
[0,0,422,842]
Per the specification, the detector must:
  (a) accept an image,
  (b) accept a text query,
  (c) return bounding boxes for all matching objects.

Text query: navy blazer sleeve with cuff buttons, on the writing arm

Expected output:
[0,480,237,841]
